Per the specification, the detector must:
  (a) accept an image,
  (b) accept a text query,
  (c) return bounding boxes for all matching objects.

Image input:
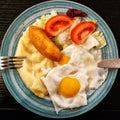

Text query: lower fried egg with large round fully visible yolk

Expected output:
[42,64,88,113]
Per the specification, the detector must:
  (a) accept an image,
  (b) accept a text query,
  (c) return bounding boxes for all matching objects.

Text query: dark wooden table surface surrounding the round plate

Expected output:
[0,0,120,120]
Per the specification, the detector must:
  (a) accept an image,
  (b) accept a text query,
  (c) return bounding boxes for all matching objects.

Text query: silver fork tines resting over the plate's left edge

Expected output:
[0,56,26,70]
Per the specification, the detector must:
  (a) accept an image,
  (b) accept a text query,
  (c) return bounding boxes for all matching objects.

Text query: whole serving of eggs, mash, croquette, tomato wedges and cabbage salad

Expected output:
[16,11,107,113]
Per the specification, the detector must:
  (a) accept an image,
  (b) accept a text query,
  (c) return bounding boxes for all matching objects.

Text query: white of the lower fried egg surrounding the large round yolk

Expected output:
[42,64,88,113]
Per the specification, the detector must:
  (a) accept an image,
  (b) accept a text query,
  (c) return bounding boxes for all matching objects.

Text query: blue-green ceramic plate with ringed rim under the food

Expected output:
[1,0,118,118]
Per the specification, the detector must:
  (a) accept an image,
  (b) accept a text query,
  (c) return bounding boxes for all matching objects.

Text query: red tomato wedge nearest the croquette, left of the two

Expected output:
[45,14,72,36]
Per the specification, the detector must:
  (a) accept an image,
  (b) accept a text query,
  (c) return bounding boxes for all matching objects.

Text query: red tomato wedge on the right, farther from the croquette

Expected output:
[71,21,97,44]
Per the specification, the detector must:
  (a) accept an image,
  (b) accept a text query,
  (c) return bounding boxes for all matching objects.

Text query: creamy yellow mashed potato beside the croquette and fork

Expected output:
[15,20,53,97]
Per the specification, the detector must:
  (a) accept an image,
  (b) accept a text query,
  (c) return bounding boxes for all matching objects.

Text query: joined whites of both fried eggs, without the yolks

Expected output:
[42,44,107,113]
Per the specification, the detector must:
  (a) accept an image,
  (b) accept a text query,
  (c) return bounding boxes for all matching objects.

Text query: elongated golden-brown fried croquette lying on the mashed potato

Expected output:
[29,26,61,61]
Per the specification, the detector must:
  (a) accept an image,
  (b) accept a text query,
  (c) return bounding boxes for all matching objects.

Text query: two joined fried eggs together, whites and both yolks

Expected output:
[42,44,108,113]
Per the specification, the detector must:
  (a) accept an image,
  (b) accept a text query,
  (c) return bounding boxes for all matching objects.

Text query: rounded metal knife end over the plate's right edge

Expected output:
[98,59,120,68]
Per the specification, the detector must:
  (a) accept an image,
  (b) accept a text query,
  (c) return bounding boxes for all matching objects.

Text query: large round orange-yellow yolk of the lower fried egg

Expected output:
[58,77,80,98]
